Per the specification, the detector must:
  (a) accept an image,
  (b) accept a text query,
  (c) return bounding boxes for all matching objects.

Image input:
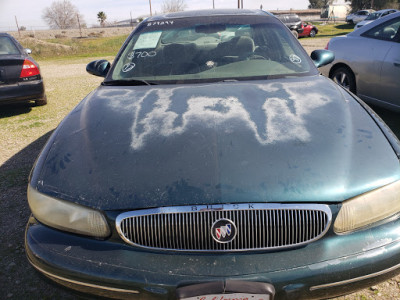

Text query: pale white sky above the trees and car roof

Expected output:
[0,0,309,31]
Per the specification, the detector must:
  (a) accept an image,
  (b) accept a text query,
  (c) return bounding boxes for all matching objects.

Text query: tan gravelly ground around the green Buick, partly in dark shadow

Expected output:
[0,39,400,300]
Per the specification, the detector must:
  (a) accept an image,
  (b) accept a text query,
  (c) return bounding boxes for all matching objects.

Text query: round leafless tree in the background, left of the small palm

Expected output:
[42,0,84,29]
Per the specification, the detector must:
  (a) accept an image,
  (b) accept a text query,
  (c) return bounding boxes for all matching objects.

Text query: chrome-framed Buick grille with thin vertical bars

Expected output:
[116,204,332,251]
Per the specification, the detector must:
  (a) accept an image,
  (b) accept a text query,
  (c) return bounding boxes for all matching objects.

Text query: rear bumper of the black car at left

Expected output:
[0,79,45,104]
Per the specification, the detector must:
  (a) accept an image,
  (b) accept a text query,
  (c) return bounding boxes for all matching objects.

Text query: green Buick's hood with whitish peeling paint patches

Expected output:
[31,76,399,210]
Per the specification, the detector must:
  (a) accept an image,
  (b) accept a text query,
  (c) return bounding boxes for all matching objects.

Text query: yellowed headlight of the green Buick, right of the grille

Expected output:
[333,181,400,234]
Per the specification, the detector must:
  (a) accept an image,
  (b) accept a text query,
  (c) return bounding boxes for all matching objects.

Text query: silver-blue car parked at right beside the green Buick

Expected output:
[320,12,400,110]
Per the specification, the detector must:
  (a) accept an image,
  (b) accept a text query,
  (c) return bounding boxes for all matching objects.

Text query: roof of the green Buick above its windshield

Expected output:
[146,9,273,22]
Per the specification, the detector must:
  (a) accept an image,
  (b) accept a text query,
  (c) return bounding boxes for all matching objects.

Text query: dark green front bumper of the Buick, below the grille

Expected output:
[26,214,400,299]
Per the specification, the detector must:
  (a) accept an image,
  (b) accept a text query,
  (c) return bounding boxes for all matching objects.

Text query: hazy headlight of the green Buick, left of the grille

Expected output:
[28,185,110,238]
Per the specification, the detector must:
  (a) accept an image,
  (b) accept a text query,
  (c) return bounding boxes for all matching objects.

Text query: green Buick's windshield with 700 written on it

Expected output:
[108,16,317,83]
